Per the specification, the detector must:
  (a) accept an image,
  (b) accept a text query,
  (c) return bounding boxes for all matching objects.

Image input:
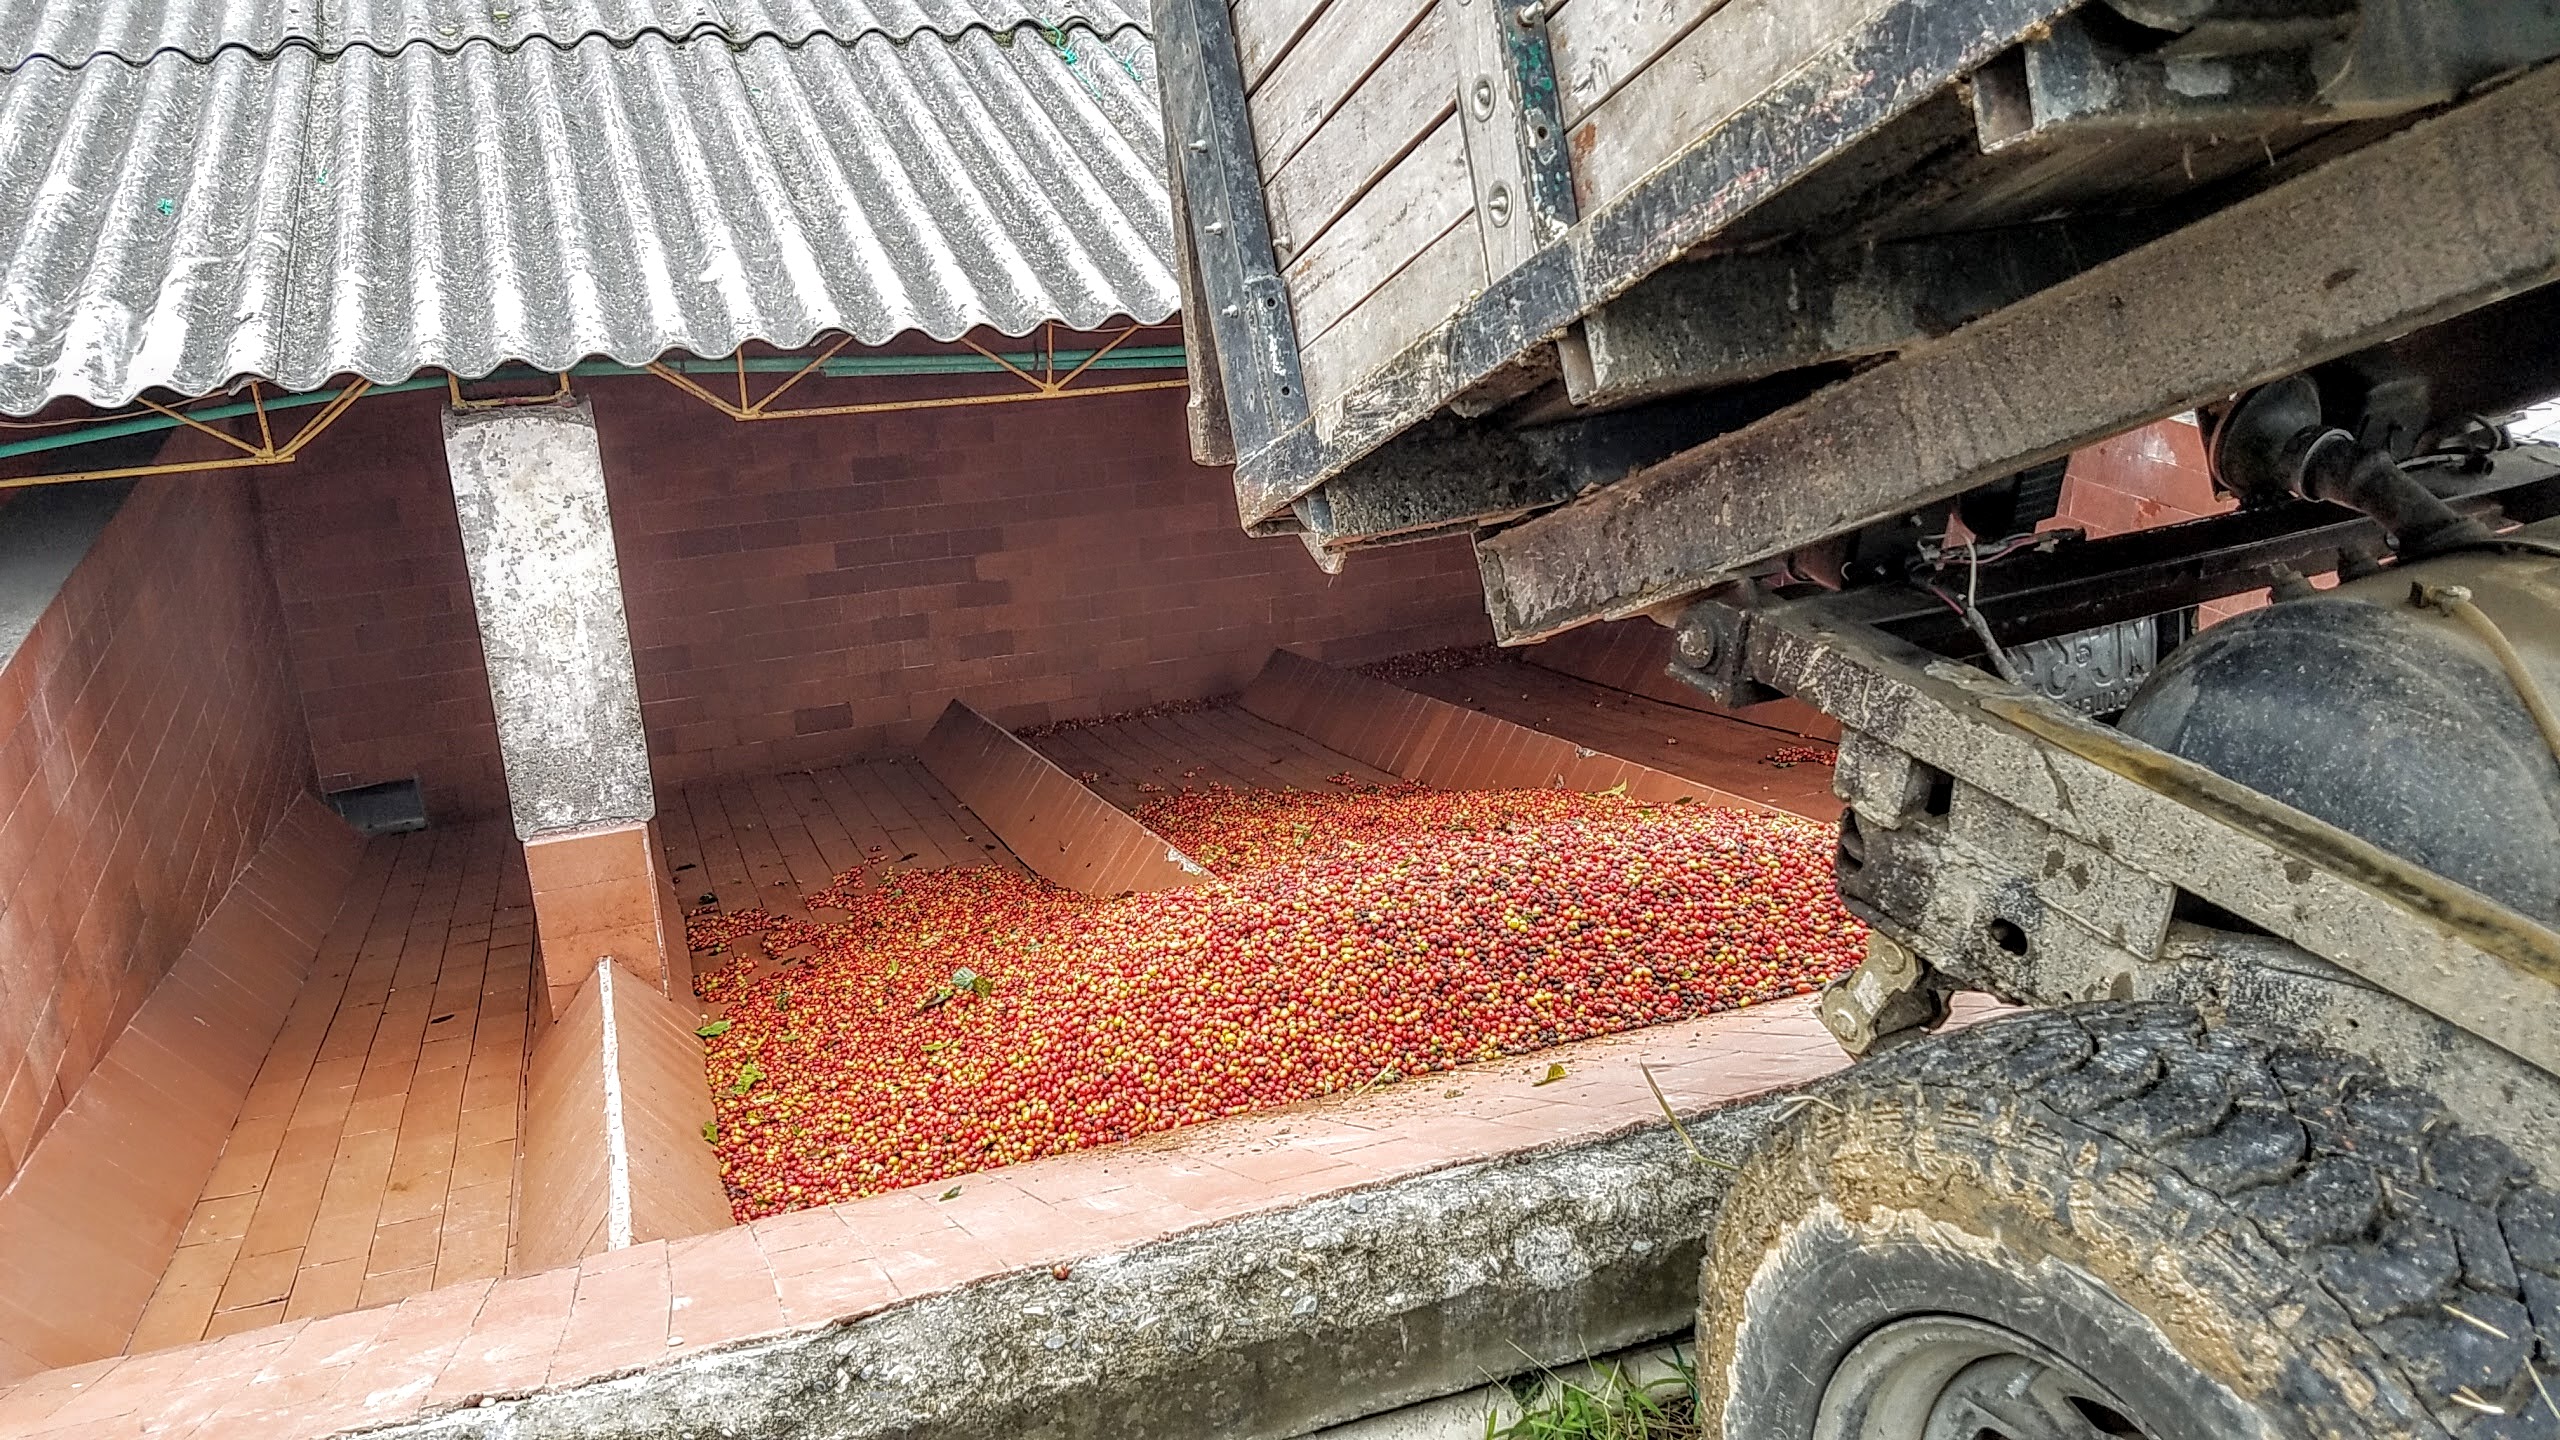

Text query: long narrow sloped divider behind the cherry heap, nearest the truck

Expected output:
[1244,651,1772,815]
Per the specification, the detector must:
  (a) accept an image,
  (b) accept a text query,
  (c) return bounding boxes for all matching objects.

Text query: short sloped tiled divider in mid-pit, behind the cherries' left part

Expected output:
[916,700,1208,894]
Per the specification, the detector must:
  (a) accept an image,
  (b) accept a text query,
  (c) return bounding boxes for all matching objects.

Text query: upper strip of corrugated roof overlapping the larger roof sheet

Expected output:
[0,0,1147,69]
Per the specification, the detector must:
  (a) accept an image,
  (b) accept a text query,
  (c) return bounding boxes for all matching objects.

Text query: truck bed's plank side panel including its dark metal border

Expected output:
[1157,0,2074,528]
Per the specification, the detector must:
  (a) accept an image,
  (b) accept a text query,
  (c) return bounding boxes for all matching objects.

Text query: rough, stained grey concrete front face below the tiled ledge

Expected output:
[374,1102,1772,1440]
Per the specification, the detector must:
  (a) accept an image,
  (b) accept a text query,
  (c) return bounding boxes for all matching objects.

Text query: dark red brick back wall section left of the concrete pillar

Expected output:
[251,389,507,817]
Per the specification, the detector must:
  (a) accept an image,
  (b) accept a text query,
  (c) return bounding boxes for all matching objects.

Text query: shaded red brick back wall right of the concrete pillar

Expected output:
[586,379,1490,784]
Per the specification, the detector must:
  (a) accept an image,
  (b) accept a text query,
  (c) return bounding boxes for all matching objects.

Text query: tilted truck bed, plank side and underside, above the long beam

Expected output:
[1157,0,2560,602]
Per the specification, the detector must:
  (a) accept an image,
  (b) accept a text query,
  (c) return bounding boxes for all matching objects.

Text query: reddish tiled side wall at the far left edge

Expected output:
[0,474,310,1181]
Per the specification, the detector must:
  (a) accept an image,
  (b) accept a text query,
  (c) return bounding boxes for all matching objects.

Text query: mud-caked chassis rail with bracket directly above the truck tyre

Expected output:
[1746,589,2560,1074]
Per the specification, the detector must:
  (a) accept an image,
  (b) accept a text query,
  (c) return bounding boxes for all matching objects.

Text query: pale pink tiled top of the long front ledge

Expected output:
[0,983,1925,1440]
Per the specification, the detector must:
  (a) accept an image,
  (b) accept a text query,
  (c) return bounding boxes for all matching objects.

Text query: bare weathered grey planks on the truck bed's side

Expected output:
[1234,0,1882,413]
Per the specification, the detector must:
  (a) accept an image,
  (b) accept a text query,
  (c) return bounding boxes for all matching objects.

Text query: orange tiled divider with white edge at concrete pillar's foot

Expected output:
[515,958,732,1271]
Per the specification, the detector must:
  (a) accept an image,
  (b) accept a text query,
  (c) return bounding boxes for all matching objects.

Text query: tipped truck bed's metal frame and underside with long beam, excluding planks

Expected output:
[1160,0,2560,602]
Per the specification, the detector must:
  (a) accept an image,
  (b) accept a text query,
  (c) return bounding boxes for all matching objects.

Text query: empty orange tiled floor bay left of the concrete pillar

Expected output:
[133,825,532,1353]
